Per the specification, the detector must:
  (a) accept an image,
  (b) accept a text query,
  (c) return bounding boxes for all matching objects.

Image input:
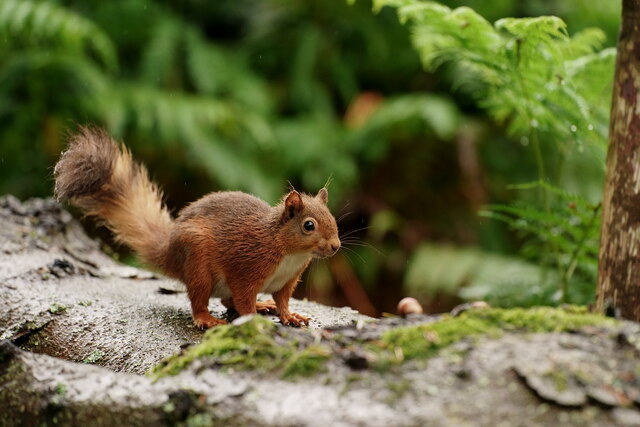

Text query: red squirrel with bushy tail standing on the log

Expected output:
[54,127,340,329]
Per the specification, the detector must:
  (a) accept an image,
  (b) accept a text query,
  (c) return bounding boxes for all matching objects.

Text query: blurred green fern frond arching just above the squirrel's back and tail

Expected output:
[109,84,280,199]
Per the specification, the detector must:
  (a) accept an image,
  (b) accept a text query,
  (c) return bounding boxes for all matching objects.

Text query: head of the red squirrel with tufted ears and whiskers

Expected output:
[280,188,340,258]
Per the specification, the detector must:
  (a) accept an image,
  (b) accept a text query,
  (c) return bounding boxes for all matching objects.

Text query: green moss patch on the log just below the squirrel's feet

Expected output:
[149,316,330,379]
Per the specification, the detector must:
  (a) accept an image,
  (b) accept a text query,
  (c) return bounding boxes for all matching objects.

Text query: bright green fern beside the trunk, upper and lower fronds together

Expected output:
[374,0,615,303]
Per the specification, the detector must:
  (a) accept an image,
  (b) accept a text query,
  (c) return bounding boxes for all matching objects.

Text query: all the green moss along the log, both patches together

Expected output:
[149,307,615,379]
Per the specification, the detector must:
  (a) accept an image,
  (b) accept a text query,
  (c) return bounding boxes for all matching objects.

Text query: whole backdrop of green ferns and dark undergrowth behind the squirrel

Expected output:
[0,0,619,310]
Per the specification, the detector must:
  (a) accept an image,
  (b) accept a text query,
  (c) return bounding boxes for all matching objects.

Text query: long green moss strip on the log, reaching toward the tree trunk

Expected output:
[374,306,615,365]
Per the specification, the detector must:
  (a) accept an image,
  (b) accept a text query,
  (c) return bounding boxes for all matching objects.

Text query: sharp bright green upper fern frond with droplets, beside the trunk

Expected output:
[374,0,615,160]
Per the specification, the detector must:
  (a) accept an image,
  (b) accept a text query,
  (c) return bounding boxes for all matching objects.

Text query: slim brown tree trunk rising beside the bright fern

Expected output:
[597,0,640,321]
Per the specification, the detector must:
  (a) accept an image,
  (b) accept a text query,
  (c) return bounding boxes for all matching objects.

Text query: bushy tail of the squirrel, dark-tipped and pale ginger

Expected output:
[54,127,172,267]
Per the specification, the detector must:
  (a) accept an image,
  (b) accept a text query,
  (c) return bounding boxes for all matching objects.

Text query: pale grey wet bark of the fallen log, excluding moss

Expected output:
[0,197,640,426]
